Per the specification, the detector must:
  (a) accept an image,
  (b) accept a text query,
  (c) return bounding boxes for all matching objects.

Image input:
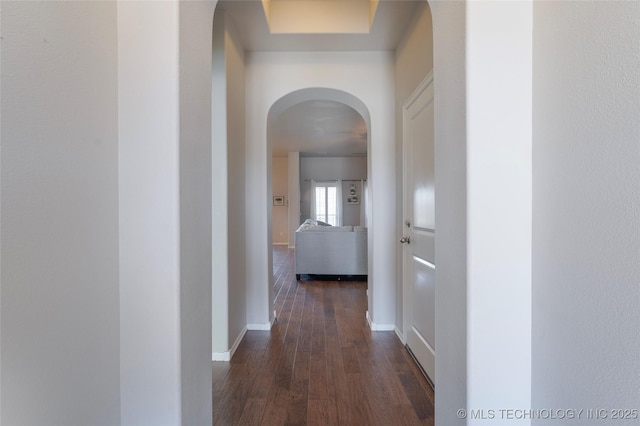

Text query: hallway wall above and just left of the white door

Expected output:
[395,2,433,331]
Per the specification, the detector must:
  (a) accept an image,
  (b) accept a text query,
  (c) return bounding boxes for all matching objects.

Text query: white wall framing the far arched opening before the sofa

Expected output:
[246,52,396,325]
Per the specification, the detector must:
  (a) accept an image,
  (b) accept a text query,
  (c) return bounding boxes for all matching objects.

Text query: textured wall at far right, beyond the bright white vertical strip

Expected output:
[532,2,640,424]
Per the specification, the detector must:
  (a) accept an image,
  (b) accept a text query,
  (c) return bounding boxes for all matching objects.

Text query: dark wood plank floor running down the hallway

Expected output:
[213,247,433,426]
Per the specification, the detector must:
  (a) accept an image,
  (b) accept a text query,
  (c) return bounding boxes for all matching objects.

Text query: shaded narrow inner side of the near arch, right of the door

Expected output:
[429,2,467,425]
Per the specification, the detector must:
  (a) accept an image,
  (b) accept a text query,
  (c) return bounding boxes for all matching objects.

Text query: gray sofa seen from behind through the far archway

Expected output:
[295,219,367,280]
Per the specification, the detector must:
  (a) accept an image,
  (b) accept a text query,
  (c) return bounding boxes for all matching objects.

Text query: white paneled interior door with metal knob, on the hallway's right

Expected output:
[400,74,436,382]
